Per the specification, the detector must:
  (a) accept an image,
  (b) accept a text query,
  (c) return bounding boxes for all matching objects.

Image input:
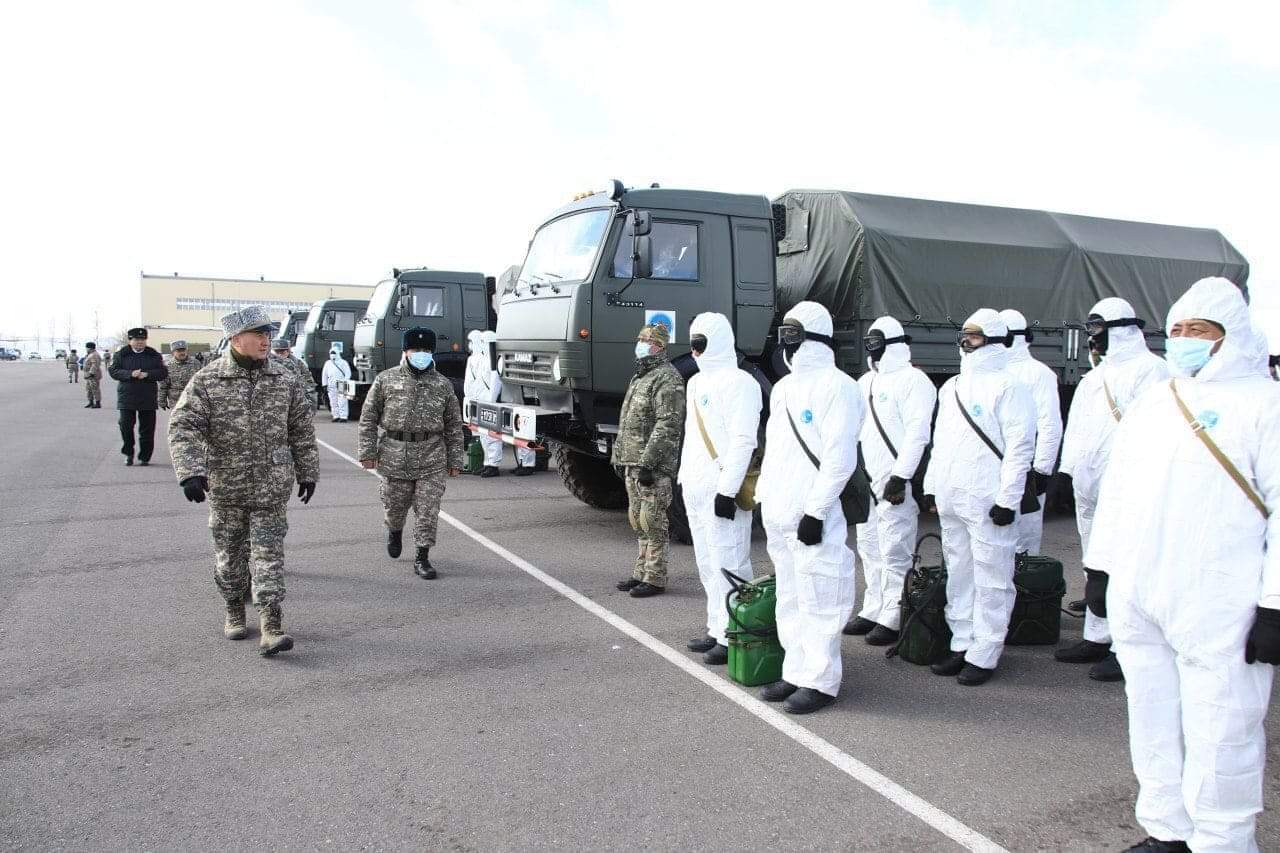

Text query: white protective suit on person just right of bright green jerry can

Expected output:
[752,302,864,695]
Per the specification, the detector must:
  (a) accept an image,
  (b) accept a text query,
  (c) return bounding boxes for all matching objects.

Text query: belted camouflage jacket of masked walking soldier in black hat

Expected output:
[360,364,462,480]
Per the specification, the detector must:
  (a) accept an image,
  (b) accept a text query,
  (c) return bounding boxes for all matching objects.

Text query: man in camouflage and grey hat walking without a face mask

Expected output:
[169,305,320,656]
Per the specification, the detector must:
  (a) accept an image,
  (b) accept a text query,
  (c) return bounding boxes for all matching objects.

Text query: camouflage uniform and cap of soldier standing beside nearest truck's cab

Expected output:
[611,327,685,587]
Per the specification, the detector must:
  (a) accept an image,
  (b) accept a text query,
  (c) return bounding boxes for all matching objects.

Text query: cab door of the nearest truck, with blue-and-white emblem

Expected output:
[591,210,733,404]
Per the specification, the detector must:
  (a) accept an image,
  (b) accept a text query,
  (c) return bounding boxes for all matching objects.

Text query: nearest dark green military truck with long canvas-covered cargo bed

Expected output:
[466,181,1248,535]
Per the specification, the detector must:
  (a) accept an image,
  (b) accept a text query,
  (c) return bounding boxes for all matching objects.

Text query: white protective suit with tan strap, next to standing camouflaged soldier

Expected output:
[680,314,762,646]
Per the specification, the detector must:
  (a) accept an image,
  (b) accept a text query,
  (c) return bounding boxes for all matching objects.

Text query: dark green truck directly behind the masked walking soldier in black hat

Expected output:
[338,269,494,409]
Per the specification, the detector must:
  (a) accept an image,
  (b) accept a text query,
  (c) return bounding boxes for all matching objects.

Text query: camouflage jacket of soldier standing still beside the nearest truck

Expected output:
[612,355,685,475]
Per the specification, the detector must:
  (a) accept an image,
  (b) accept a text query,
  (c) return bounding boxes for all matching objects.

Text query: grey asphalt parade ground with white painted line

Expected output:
[0,364,1280,850]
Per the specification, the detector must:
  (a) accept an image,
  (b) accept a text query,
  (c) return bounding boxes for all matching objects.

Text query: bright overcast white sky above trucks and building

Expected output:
[0,0,1280,341]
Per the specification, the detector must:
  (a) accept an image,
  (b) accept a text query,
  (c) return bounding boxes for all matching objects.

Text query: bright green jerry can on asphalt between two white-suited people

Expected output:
[721,569,783,686]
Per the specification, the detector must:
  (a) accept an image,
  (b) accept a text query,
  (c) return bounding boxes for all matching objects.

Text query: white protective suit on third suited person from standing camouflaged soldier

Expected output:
[858,316,938,630]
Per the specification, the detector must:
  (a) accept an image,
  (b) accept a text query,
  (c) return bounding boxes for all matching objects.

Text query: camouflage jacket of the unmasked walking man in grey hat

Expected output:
[169,351,320,506]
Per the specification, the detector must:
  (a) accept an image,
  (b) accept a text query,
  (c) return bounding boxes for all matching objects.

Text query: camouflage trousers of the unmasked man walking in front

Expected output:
[209,503,289,607]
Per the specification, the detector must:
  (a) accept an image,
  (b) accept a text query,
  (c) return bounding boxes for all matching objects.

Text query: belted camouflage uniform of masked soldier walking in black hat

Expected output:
[360,364,462,548]
